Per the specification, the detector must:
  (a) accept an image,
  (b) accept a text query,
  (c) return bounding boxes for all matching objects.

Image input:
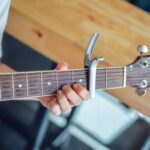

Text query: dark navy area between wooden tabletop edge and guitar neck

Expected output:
[2,34,56,71]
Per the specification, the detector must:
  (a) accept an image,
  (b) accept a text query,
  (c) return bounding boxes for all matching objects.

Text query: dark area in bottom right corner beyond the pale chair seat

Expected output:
[110,119,150,150]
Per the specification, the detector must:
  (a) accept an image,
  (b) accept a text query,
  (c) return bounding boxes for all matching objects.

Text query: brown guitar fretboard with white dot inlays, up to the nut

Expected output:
[0,67,127,100]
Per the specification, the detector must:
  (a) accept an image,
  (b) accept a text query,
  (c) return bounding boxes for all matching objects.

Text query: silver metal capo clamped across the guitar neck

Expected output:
[84,33,104,98]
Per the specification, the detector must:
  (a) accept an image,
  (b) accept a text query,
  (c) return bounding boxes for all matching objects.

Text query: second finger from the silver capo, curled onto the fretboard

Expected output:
[62,85,81,106]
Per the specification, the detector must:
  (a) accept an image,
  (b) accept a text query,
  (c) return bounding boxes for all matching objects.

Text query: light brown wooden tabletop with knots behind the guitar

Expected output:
[6,0,150,116]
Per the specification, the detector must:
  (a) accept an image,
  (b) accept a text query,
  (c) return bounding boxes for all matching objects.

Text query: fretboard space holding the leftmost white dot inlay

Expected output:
[13,73,28,98]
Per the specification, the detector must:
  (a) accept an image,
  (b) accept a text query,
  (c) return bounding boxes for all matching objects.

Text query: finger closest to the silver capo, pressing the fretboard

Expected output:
[73,83,90,100]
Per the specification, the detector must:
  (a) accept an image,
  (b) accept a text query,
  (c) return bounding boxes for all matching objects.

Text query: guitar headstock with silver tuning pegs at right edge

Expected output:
[126,45,150,96]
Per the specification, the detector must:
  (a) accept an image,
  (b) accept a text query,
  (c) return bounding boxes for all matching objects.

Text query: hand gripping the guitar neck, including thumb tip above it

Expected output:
[40,63,90,115]
